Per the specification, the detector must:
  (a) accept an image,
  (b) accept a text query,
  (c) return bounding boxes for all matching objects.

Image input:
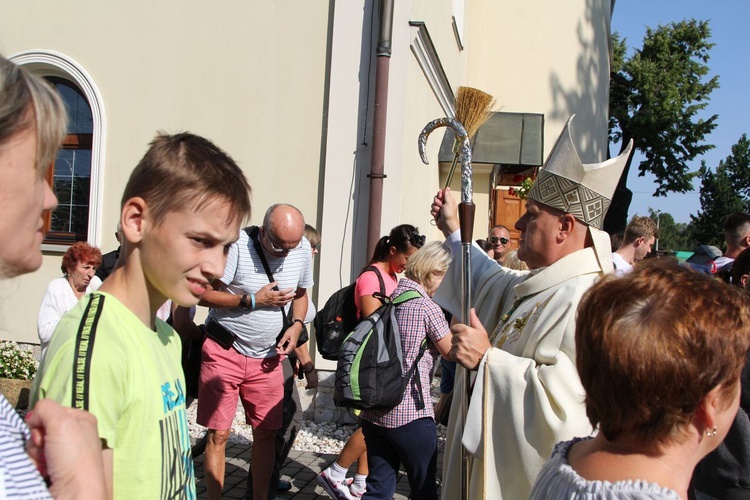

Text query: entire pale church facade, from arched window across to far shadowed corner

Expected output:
[0,0,610,348]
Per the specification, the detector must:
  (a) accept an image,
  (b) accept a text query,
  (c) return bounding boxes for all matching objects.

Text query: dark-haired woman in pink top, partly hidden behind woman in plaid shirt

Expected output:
[318,224,425,499]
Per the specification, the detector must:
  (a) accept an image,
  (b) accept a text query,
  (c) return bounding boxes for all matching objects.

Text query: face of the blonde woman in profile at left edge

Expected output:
[0,125,57,278]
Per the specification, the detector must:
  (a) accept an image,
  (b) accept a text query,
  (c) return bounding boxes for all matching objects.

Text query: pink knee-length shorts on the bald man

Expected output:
[197,338,284,431]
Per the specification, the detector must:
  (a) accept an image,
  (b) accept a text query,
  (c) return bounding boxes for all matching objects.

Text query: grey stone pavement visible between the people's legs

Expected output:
[194,436,443,500]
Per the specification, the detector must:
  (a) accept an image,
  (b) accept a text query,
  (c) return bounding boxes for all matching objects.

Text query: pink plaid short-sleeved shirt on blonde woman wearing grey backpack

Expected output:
[362,278,450,429]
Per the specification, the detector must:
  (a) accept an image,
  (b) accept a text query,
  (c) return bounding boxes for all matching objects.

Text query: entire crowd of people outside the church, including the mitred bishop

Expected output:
[0,51,750,500]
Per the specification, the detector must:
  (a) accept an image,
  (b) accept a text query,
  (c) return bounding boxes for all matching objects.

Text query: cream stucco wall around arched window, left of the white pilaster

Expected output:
[0,0,329,341]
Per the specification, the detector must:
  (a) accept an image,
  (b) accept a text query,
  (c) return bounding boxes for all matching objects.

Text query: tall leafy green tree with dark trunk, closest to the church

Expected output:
[604,19,719,232]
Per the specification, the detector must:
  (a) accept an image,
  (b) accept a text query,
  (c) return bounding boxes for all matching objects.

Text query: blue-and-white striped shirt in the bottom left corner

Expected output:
[0,394,52,498]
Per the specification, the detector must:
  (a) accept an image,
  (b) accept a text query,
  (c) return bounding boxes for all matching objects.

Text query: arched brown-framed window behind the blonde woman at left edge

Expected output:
[44,77,94,244]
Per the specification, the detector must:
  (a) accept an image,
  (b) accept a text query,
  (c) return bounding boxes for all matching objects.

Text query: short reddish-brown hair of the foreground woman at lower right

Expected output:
[576,259,750,443]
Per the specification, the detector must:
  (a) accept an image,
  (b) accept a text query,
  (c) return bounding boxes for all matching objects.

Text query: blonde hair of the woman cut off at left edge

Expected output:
[0,56,67,172]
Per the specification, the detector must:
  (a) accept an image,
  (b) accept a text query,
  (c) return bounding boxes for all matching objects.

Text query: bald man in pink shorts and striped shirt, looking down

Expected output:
[197,204,313,500]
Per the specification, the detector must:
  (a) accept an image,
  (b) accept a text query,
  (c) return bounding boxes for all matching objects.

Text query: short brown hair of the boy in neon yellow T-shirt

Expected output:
[121,132,251,225]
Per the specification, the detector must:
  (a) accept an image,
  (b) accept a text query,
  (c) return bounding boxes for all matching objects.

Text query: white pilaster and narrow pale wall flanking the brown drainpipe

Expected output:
[317,0,461,302]
